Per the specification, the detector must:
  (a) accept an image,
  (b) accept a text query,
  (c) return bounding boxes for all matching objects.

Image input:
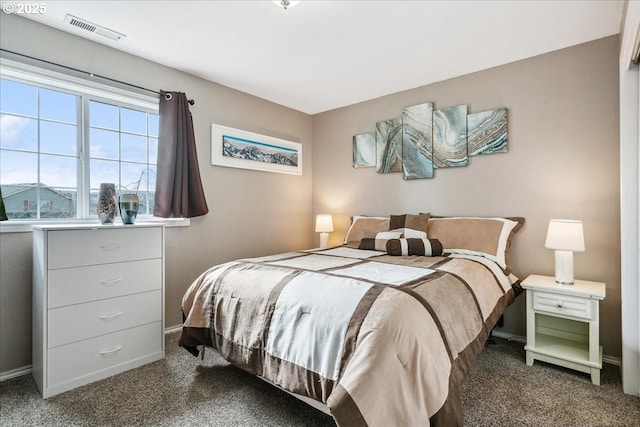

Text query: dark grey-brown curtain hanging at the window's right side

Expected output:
[154,92,209,218]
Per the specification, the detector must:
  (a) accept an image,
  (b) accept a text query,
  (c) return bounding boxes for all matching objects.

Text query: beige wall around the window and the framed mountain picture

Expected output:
[0,14,313,373]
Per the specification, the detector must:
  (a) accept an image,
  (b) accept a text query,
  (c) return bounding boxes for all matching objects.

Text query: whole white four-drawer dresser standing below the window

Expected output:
[33,224,164,398]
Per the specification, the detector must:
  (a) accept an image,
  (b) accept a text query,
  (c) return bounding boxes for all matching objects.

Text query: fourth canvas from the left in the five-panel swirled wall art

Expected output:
[433,105,469,168]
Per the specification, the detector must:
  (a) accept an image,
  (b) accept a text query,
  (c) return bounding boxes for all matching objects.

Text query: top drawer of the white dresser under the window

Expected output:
[47,227,162,269]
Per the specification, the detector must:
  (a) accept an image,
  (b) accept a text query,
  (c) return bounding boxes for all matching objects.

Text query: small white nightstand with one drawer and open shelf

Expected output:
[522,275,606,385]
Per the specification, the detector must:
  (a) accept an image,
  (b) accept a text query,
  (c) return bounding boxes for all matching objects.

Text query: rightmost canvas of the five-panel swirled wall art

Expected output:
[467,108,507,156]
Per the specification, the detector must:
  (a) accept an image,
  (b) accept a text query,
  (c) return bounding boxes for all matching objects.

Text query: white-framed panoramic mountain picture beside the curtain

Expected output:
[211,123,302,175]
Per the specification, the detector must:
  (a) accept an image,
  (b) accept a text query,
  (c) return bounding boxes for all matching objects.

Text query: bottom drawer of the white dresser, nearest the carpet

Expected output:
[47,322,164,387]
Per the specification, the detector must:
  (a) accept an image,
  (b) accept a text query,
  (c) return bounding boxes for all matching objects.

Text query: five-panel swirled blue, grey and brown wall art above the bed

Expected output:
[353,102,507,180]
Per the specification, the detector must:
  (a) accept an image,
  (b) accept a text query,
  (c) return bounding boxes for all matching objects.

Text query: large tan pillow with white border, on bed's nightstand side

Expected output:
[427,217,524,272]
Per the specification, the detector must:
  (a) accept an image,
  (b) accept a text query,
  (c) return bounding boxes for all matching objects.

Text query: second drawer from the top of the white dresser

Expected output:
[47,258,162,308]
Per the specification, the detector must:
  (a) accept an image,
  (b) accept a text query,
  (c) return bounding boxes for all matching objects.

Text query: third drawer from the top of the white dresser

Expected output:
[47,290,162,348]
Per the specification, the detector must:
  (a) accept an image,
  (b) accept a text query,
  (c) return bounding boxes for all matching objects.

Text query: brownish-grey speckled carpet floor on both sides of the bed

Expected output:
[0,332,640,427]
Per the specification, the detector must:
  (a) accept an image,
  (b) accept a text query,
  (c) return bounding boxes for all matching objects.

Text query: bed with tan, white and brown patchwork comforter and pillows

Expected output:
[180,214,524,427]
